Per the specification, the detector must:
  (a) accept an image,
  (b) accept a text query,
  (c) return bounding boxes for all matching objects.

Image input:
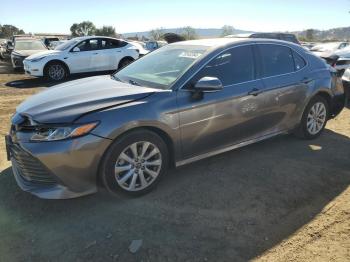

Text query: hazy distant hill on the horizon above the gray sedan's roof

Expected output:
[122,28,251,38]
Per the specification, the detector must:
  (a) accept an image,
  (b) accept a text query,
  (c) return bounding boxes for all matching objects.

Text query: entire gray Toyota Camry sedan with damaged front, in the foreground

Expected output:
[6,38,344,199]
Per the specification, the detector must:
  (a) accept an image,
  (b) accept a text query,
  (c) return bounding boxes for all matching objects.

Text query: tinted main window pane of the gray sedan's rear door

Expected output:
[258,44,294,77]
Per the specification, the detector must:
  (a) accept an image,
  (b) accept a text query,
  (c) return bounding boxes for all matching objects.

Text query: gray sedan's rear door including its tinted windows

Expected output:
[257,44,312,132]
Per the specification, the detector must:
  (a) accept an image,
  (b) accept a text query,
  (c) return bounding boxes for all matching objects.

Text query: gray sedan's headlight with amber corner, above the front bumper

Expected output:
[31,122,98,141]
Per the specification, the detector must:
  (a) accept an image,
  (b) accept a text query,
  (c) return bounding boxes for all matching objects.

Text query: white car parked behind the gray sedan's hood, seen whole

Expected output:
[23,36,139,81]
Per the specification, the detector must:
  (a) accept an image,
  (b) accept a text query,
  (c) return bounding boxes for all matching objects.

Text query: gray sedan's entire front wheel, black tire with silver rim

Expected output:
[100,129,169,196]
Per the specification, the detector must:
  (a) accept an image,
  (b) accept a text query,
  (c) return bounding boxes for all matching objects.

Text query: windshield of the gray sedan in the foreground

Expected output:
[114,45,209,89]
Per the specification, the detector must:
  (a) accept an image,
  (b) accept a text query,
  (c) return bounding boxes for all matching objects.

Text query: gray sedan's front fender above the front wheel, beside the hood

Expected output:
[78,90,181,161]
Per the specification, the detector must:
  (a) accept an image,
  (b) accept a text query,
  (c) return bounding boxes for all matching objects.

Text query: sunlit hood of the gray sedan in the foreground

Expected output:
[16,76,159,124]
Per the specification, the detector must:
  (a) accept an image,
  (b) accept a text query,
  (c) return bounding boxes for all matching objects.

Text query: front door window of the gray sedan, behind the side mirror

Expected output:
[193,46,255,86]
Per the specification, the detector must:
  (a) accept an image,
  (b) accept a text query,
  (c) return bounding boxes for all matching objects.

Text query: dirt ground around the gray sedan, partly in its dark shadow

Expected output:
[0,59,350,262]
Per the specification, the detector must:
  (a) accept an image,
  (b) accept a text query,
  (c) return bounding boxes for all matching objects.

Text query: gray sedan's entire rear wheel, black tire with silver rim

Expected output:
[295,96,329,140]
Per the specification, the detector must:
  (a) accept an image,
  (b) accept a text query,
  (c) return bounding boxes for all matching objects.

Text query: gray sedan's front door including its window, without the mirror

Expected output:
[177,45,270,158]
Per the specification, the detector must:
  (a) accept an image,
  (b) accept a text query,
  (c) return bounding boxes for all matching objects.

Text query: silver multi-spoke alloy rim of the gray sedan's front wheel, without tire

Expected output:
[115,141,162,191]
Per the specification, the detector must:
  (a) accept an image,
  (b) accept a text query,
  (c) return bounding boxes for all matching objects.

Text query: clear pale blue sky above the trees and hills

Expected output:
[0,0,350,33]
